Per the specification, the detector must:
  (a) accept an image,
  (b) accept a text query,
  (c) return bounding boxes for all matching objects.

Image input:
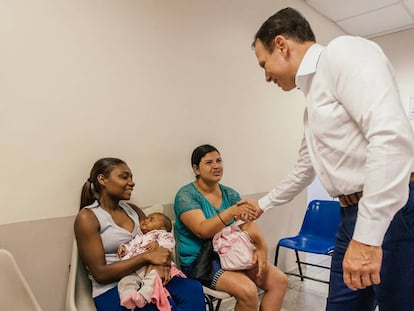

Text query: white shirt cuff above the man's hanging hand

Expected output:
[352,215,390,246]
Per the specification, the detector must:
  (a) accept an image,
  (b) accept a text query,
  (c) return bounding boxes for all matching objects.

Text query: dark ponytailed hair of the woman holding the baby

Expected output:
[79,158,126,210]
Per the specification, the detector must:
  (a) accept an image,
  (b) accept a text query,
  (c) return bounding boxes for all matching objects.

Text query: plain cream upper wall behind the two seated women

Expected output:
[0,0,339,224]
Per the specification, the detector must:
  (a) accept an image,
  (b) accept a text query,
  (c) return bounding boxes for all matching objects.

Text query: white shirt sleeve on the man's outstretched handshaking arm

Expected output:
[259,138,315,212]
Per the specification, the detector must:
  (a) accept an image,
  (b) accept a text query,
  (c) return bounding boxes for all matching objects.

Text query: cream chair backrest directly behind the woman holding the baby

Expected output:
[65,240,96,311]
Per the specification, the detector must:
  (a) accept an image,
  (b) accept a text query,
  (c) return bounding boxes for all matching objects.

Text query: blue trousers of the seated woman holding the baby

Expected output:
[94,277,206,311]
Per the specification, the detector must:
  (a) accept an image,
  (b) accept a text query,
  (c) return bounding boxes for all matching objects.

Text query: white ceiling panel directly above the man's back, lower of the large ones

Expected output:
[338,4,413,36]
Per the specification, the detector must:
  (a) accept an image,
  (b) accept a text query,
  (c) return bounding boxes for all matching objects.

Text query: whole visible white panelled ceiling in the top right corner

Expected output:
[305,0,414,38]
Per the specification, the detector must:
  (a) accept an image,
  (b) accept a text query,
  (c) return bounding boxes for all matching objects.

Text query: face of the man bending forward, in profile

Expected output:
[254,39,296,91]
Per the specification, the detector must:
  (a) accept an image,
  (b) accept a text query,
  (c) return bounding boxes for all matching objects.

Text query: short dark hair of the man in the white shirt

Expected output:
[252,8,316,53]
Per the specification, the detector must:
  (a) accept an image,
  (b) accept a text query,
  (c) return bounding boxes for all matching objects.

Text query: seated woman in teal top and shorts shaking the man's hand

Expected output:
[174,145,287,311]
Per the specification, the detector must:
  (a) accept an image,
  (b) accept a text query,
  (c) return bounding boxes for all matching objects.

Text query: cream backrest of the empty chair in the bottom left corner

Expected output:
[0,249,42,311]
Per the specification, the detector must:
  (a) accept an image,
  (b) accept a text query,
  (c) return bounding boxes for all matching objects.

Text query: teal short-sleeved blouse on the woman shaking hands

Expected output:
[174,182,241,266]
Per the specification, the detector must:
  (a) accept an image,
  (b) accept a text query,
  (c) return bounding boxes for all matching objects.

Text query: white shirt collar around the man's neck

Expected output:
[295,43,324,91]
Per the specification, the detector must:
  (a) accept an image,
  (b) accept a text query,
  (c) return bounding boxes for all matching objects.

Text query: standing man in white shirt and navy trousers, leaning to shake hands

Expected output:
[241,8,414,311]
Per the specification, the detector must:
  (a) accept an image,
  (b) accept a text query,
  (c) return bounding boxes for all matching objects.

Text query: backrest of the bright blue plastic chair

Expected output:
[299,200,341,242]
